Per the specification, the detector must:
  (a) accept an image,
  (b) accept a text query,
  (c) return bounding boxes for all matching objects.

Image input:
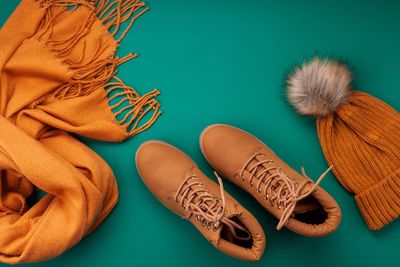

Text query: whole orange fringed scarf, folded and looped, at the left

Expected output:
[0,0,160,263]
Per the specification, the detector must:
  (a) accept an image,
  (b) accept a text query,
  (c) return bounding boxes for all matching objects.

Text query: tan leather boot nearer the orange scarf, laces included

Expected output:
[136,141,266,261]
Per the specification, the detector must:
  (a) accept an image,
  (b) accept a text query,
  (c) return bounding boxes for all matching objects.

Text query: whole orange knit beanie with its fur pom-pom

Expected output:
[288,58,400,230]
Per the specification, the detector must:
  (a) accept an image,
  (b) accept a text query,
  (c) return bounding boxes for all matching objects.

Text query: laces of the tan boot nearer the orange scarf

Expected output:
[175,172,251,240]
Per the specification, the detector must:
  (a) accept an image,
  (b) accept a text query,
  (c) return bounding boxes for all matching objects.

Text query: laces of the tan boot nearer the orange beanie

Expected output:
[239,152,333,230]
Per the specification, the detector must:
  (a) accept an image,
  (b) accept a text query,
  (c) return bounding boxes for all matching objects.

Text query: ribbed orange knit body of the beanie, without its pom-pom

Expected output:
[317,91,400,230]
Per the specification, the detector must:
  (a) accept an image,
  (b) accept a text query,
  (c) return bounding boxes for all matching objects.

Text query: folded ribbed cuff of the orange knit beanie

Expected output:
[355,169,400,230]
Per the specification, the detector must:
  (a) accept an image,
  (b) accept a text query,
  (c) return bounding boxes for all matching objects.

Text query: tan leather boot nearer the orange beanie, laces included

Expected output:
[200,124,341,237]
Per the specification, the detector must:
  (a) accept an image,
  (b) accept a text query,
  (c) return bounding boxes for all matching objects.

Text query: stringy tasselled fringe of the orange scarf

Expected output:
[36,0,161,136]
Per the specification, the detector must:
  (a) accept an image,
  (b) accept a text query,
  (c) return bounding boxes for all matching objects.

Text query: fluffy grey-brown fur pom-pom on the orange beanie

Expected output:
[287,57,352,117]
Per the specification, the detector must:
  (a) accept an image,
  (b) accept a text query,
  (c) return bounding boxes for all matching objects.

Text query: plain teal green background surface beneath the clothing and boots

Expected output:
[0,0,400,267]
